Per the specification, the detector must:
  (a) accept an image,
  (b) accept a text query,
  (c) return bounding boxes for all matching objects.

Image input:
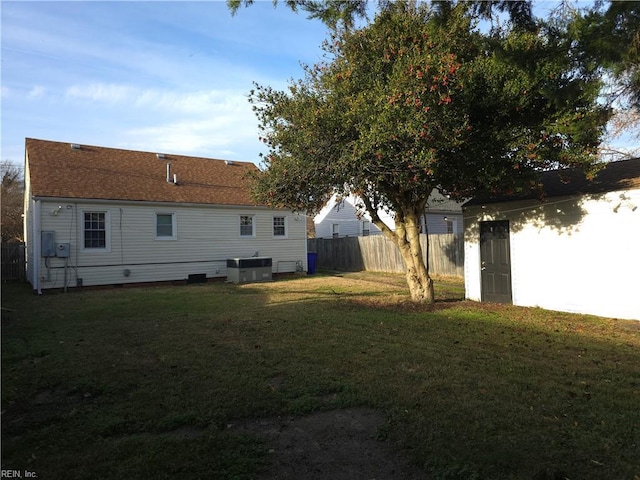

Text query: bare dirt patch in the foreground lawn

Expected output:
[230,408,425,480]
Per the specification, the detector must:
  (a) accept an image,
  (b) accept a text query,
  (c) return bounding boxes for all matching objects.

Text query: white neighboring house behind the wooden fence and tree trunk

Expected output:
[313,190,462,238]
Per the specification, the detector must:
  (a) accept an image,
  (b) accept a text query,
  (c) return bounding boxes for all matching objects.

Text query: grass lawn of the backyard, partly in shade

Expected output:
[2,272,640,480]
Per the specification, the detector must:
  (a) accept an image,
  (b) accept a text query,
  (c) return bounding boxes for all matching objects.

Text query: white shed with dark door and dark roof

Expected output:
[464,159,640,320]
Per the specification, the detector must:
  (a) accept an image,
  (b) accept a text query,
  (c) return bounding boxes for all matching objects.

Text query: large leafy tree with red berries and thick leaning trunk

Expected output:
[251,2,609,302]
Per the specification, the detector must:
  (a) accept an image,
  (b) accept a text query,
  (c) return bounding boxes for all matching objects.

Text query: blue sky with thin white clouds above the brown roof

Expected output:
[0,0,336,171]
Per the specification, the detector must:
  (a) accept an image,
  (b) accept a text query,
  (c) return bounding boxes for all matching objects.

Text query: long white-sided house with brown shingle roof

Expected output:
[24,138,307,292]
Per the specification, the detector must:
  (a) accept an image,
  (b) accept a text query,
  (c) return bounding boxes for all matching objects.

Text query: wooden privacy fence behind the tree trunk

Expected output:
[307,233,464,277]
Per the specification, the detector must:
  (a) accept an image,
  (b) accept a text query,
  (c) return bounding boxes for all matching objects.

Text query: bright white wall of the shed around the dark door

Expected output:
[465,190,640,319]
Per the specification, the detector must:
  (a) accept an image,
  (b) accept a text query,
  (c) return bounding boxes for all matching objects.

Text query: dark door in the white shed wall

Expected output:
[480,220,511,303]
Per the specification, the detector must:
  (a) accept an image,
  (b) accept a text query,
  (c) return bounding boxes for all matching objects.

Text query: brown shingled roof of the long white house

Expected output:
[26,138,257,205]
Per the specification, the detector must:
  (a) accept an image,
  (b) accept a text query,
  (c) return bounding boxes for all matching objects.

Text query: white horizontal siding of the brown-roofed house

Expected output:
[30,199,307,289]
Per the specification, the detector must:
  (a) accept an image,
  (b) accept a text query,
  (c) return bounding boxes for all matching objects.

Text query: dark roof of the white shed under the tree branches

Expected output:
[465,158,640,206]
